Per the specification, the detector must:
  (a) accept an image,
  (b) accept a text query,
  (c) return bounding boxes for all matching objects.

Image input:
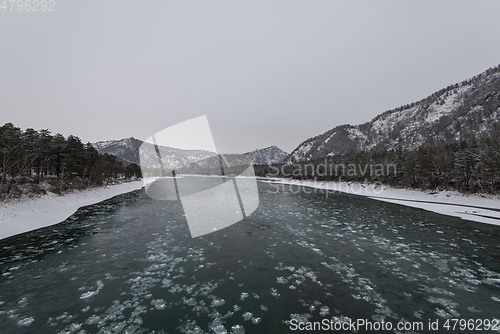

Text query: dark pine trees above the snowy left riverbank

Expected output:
[0,123,141,200]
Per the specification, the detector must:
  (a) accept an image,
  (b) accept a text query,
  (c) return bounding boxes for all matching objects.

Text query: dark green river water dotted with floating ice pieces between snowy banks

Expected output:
[0,179,500,333]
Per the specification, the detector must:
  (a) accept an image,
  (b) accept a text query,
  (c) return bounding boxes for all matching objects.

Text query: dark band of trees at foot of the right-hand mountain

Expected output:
[255,136,500,194]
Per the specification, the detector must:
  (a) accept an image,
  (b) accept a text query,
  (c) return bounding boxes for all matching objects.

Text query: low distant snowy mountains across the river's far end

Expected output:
[93,137,288,169]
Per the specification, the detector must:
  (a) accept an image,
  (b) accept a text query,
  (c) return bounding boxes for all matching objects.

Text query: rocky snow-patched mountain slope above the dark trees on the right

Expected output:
[285,65,500,164]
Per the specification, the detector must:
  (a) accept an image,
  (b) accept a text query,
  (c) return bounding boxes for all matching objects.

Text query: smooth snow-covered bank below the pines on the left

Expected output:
[0,181,144,239]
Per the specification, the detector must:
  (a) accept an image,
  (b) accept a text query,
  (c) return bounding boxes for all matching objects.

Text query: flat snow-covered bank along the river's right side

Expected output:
[261,179,500,226]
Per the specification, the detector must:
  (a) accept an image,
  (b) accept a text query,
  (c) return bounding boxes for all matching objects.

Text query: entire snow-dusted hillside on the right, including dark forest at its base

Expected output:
[264,65,500,194]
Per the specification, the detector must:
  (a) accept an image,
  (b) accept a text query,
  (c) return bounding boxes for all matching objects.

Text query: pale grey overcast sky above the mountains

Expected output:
[0,0,500,153]
